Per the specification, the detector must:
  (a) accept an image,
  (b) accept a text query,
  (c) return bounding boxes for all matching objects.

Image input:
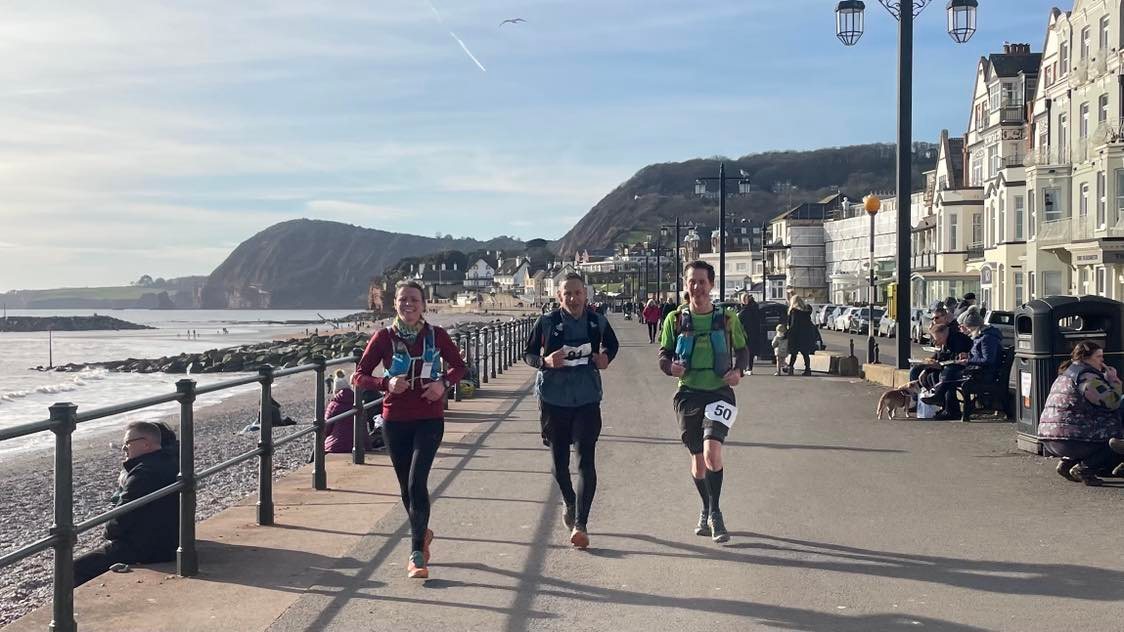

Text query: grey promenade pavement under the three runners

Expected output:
[12,318,1124,632]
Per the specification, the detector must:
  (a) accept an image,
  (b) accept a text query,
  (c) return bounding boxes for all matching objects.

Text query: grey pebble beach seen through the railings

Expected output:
[0,314,526,626]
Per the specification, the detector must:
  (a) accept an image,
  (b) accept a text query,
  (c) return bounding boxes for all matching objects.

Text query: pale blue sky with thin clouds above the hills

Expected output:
[0,0,1072,292]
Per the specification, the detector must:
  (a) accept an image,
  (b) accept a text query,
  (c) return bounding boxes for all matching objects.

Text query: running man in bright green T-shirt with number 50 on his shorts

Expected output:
[660,261,749,542]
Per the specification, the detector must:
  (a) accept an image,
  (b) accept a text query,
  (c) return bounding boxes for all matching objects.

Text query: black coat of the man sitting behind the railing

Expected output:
[106,451,180,555]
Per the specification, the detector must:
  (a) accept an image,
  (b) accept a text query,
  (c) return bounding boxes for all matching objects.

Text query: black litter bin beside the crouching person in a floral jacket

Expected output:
[1012,296,1124,453]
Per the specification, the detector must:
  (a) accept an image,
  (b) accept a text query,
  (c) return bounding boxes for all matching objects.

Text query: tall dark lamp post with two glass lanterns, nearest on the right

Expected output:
[835,0,979,369]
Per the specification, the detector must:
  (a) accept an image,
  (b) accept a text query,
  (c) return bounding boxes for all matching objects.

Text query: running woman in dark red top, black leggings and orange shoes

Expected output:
[353,281,465,579]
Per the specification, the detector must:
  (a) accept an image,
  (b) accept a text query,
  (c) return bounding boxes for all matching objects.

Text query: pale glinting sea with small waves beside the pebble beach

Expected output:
[0,309,357,452]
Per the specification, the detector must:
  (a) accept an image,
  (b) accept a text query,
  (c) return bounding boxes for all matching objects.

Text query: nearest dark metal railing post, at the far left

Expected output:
[49,403,78,632]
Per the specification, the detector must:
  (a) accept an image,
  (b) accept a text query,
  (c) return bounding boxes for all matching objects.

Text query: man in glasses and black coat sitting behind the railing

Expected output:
[74,422,180,586]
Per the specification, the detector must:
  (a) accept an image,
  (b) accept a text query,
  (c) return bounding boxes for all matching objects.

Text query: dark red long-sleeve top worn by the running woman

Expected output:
[355,324,465,422]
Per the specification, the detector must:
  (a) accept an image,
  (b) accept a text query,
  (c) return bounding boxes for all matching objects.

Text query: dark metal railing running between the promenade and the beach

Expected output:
[0,317,534,632]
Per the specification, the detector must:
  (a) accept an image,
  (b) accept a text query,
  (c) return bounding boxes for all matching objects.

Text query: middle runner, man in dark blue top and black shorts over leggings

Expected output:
[524,272,620,549]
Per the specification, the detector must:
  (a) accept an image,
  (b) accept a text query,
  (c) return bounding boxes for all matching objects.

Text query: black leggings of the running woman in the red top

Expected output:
[382,419,445,551]
